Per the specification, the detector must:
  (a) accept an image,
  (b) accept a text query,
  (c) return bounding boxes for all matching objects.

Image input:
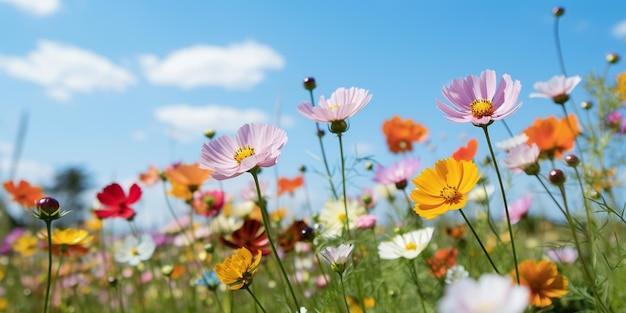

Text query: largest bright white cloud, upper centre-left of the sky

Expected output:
[139,41,285,89]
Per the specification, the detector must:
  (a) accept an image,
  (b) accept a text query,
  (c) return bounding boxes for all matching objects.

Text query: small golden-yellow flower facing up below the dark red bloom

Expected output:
[215,247,262,290]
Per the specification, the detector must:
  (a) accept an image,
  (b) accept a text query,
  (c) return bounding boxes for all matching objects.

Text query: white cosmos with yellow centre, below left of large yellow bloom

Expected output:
[378,227,435,260]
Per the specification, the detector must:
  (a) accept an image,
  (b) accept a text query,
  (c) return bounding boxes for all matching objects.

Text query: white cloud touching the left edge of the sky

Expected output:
[0,40,135,101]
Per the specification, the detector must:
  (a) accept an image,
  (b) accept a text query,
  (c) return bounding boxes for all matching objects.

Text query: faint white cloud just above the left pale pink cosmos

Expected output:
[154,104,269,141]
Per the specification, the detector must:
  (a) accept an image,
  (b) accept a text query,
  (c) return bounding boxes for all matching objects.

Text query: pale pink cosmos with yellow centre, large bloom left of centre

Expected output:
[200,124,287,180]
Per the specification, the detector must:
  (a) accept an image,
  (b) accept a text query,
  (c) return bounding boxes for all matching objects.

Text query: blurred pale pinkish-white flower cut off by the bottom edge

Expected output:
[437,274,530,313]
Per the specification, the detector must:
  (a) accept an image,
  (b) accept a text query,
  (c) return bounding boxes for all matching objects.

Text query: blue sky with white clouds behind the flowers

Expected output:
[0,0,626,229]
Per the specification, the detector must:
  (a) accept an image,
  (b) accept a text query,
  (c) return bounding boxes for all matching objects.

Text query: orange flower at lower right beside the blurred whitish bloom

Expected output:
[511,260,567,308]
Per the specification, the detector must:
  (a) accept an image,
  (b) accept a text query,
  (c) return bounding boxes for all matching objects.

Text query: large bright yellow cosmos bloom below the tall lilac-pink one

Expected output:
[411,158,481,219]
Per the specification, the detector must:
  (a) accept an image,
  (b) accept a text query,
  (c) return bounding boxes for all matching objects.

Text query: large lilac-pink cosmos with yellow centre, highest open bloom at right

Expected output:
[437,70,522,126]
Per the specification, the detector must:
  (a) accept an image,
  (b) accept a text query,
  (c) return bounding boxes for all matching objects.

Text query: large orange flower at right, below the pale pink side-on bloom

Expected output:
[524,114,580,159]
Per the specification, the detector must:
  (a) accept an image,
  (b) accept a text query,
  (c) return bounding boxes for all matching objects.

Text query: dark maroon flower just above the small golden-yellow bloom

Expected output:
[220,219,272,255]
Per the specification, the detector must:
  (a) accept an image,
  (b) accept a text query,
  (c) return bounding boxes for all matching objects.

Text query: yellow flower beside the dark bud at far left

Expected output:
[40,228,93,256]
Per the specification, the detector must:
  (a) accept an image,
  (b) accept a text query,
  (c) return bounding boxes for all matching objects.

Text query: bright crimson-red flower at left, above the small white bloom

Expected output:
[94,183,141,220]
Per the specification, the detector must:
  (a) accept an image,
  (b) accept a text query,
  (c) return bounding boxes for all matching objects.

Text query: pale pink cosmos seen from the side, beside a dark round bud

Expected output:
[298,87,372,123]
